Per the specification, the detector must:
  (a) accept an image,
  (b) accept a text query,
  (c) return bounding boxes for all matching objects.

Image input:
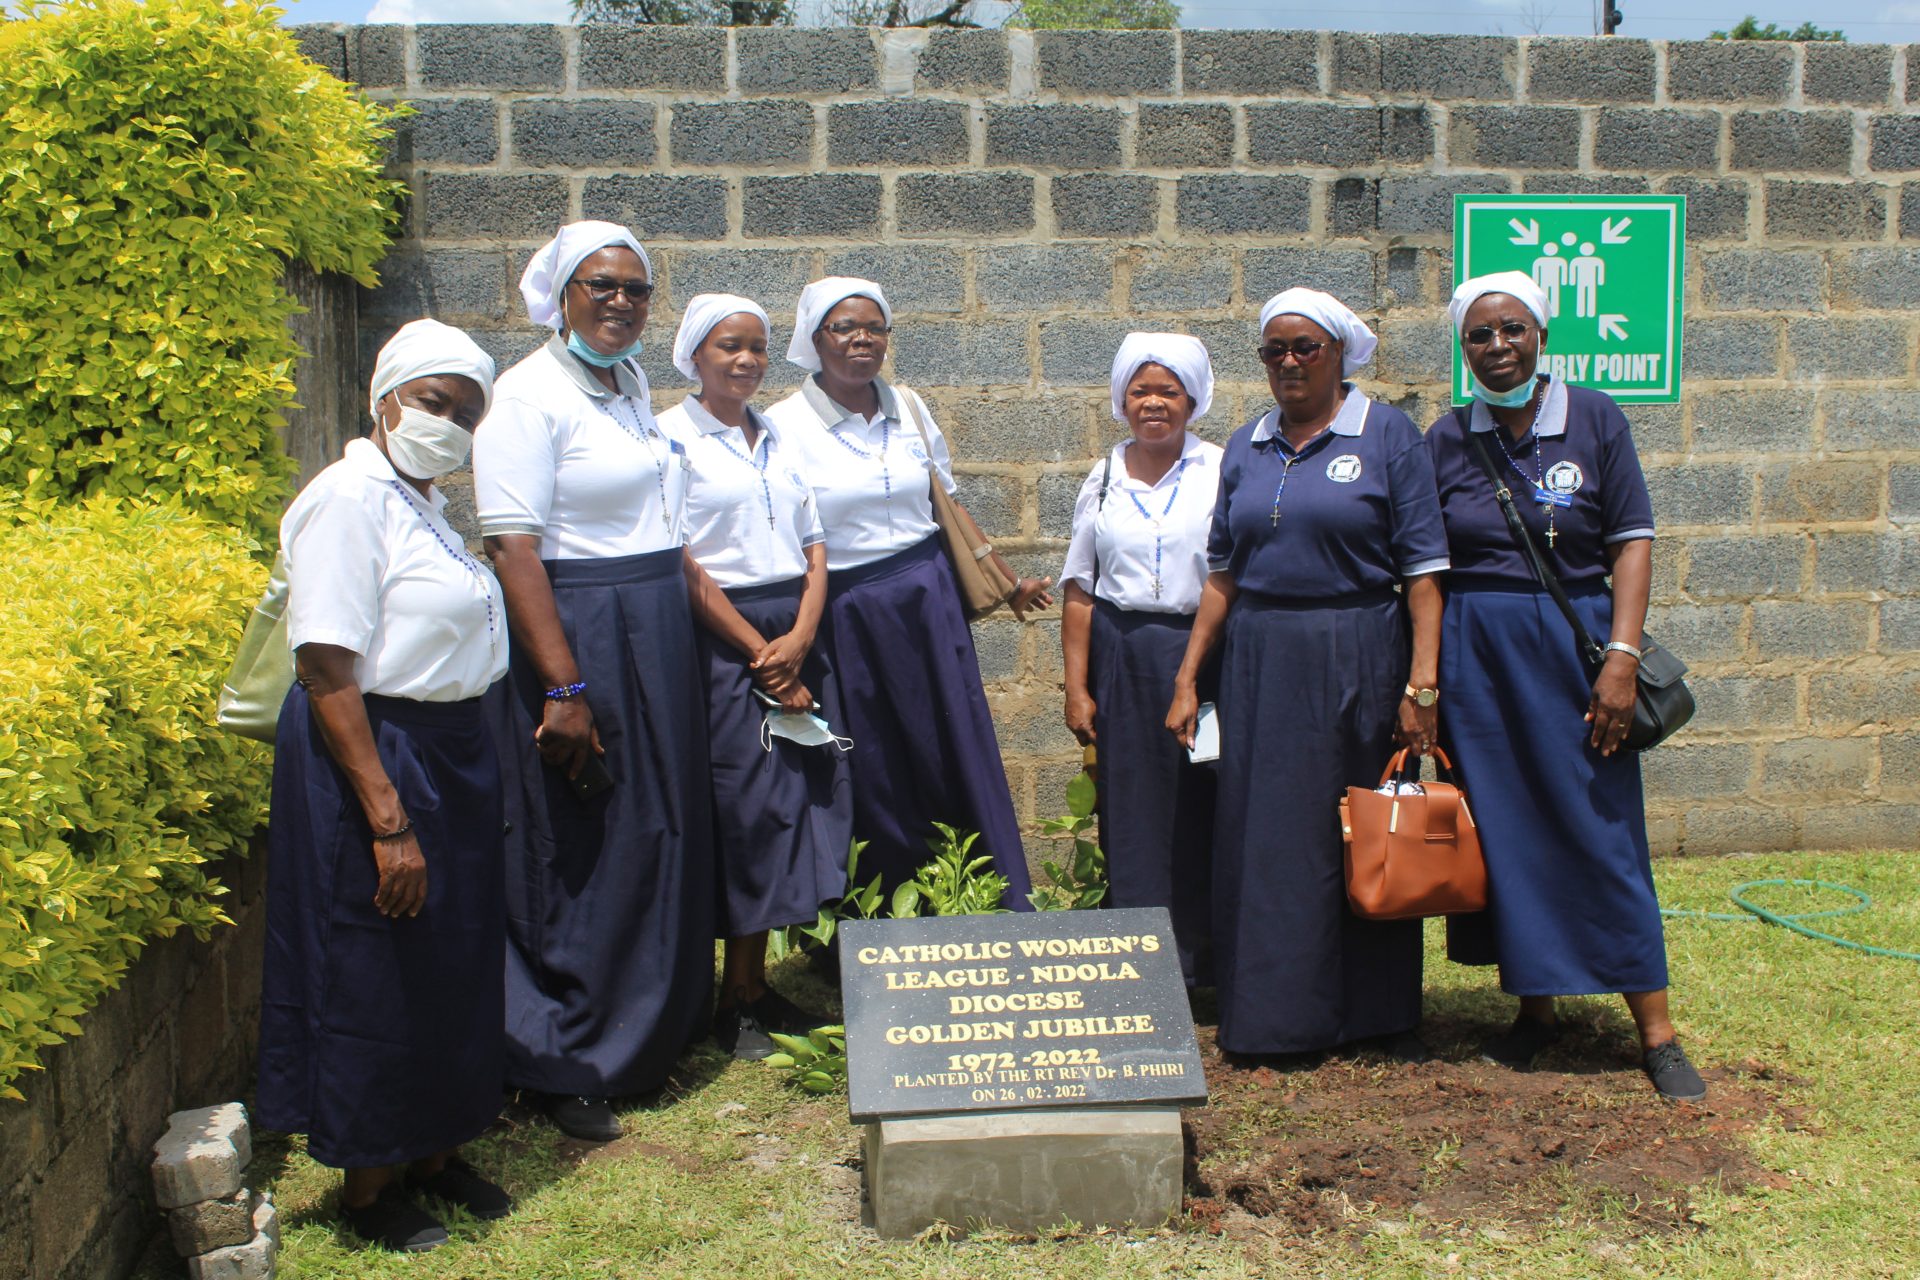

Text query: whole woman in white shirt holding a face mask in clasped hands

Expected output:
[660,294,852,1059]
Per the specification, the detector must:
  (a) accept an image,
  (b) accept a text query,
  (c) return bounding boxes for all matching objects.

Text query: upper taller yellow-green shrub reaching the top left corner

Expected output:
[0,0,399,539]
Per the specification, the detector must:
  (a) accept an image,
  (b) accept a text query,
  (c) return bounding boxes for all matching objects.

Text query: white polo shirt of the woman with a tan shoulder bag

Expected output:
[766,378,954,570]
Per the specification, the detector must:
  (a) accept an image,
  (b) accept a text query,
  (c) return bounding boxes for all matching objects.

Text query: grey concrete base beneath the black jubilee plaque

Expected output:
[866,1107,1183,1240]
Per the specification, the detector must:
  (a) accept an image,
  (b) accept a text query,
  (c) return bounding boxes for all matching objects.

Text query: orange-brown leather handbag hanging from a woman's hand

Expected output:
[1340,748,1486,919]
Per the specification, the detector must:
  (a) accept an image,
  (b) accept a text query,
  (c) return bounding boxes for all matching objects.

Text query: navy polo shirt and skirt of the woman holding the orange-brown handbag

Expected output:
[1208,395,1448,1054]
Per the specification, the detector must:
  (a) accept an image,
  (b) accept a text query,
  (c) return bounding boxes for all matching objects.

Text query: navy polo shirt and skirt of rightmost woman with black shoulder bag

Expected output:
[1427,380,1667,996]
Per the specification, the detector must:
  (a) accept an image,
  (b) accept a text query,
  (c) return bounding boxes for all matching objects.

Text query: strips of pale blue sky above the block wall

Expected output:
[282,0,1920,44]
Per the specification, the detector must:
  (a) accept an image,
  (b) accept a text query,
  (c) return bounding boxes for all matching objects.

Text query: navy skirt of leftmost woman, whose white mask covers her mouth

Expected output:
[255,685,507,1169]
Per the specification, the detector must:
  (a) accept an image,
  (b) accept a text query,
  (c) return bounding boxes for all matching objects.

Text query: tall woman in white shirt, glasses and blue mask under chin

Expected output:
[474,223,779,1142]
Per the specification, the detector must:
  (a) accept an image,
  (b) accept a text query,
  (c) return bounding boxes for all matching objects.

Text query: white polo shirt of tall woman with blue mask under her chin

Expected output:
[474,336,687,560]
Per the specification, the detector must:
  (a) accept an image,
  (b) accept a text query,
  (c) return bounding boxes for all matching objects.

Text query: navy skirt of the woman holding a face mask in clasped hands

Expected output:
[697,578,852,938]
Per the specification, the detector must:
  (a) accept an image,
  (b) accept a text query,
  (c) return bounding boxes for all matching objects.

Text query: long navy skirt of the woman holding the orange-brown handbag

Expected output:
[1213,591,1428,1054]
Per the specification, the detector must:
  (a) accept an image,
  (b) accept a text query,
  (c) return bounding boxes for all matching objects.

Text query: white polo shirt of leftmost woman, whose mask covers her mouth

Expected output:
[280,439,507,702]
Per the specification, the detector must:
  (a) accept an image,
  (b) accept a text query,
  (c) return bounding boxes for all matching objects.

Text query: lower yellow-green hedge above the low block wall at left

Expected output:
[0,499,269,1098]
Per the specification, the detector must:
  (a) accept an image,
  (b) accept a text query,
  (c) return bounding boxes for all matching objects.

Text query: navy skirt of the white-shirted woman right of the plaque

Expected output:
[1087,601,1215,986]
